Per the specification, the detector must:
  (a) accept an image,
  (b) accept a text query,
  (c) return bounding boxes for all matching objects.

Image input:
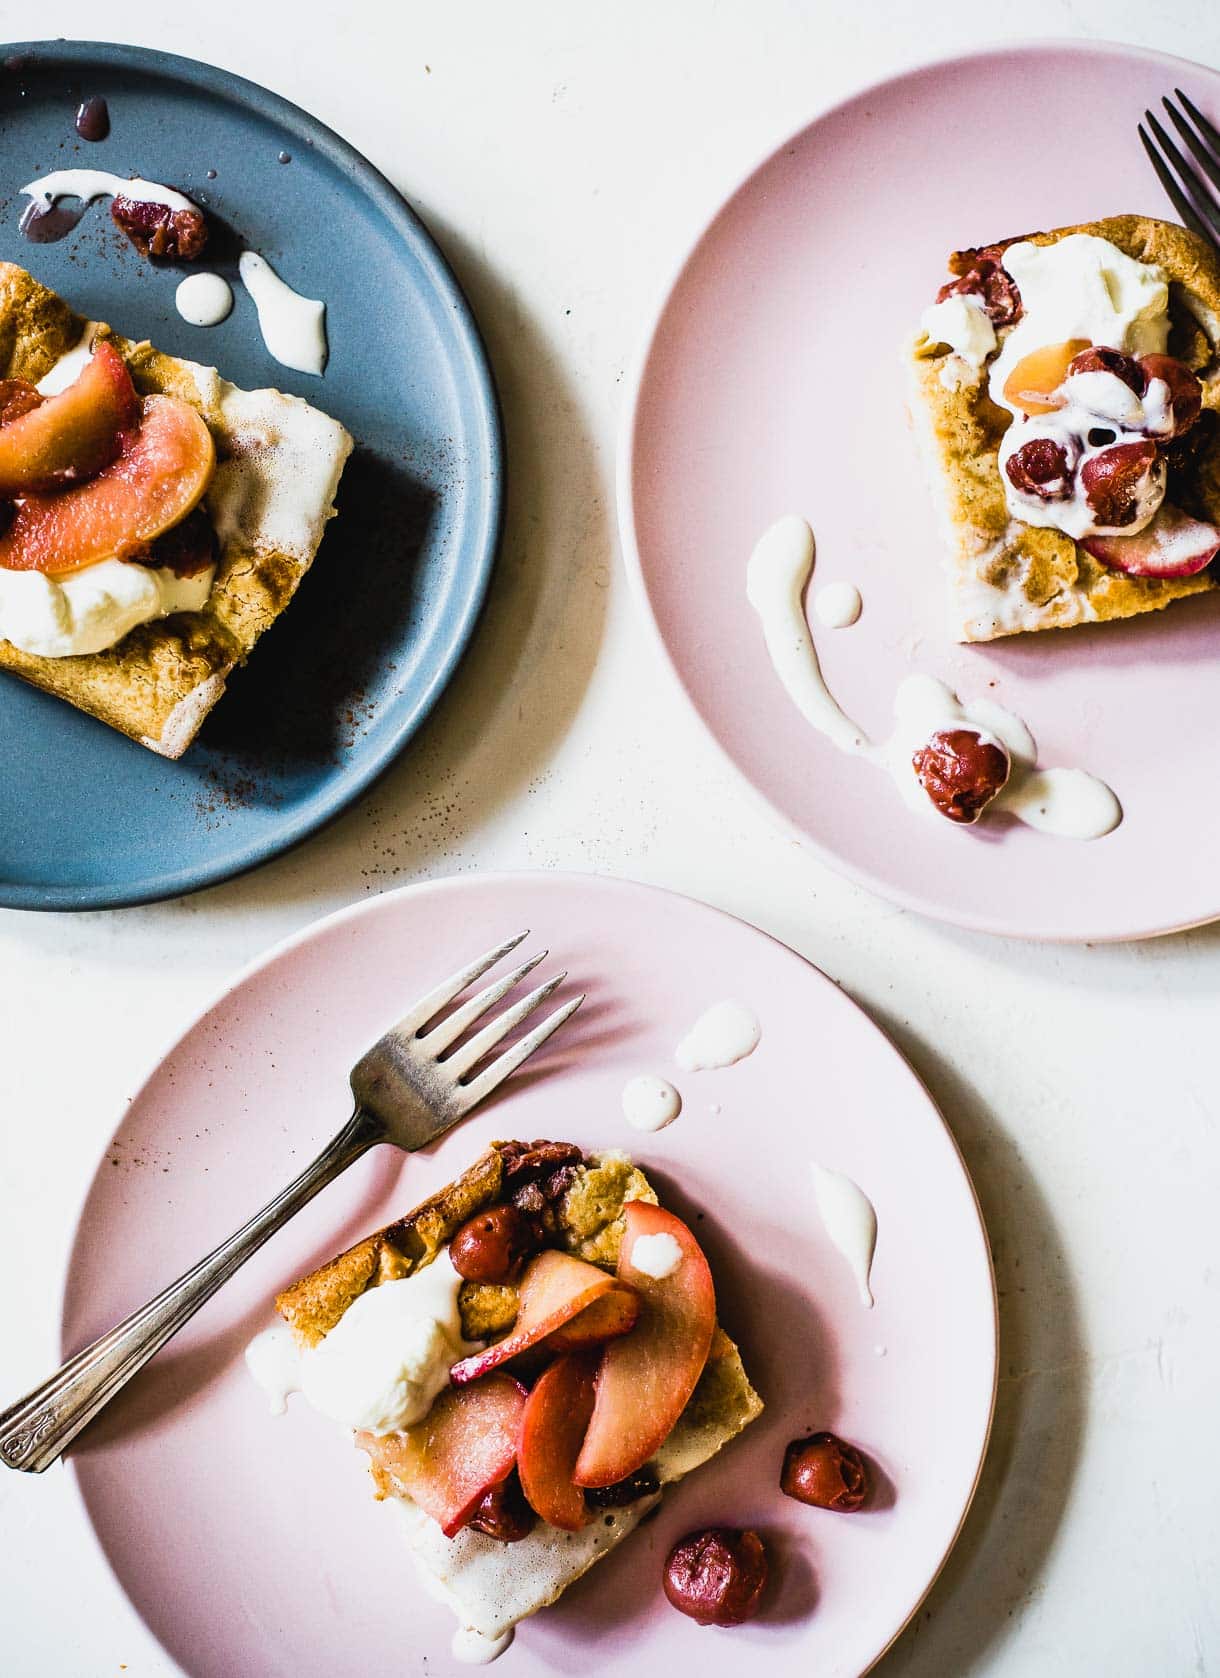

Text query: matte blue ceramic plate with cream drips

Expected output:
[0,42,502,909]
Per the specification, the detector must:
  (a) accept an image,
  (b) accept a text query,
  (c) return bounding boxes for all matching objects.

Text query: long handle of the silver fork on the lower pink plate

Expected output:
[0,1107,386,1473]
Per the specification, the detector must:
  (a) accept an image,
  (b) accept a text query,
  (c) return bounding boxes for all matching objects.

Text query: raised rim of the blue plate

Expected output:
[0,40,505,909]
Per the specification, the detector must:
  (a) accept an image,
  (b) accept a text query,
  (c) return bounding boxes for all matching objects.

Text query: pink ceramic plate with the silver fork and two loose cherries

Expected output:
[64,876,995,1678]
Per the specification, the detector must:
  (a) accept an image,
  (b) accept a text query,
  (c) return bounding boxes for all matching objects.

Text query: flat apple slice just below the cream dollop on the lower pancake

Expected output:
[356,1374,525,1539]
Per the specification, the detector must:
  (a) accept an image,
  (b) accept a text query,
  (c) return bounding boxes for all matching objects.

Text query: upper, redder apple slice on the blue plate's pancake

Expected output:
[0,339,139,497]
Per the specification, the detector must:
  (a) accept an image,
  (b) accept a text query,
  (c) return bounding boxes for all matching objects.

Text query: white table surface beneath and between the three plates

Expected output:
[0,0,1220,1678]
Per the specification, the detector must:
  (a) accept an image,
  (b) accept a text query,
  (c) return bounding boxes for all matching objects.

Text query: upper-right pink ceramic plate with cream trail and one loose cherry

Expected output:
[619,42,1220,940]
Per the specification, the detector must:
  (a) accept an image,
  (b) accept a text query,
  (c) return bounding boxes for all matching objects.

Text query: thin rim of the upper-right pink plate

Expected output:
[614,35,1220,945]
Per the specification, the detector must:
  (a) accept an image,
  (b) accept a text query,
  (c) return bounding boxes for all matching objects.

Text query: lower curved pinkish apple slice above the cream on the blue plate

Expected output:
[0,396,216,571]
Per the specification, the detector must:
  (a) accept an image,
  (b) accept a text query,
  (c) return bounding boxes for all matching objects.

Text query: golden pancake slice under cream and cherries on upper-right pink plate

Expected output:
[905,216,1220,641]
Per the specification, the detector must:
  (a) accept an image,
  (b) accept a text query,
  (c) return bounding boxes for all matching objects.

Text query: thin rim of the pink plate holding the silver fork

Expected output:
[57,869,1000,1678]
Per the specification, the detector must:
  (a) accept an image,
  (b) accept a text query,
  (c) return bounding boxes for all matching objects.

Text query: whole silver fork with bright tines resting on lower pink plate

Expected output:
[0,931,584,1473]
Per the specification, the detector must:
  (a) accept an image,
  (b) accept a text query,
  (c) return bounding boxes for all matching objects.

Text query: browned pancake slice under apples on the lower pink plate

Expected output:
[275,1143,762,1638]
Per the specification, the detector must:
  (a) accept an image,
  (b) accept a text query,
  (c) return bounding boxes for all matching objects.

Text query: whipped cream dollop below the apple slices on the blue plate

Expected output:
[0,559,215,658]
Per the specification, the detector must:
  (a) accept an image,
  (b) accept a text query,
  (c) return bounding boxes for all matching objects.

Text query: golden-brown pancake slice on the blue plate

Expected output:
[0,263,352,757]
